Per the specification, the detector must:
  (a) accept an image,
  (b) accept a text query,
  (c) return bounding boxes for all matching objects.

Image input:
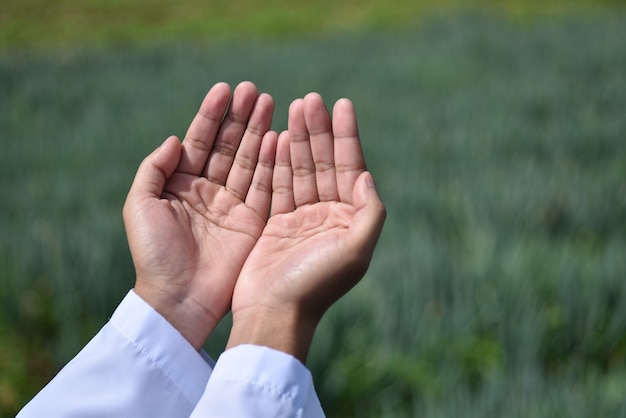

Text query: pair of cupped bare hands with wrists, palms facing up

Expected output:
[124,82,385,362]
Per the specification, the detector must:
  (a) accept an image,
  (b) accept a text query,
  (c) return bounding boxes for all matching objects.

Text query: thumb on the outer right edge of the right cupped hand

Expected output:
[350,171,387,259]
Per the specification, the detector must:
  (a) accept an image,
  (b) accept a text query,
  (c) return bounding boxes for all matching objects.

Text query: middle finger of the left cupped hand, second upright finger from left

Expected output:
[204,81,258,186]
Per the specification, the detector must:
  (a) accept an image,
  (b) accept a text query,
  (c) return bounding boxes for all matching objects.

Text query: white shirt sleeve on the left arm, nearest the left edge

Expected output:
[18,290,213,418]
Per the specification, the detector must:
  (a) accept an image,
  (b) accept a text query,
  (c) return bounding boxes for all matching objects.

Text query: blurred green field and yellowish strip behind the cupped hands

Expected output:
[0,0,626,417]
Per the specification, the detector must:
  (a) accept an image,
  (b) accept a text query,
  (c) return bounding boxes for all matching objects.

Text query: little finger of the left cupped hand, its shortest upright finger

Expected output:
[246,131,278,220]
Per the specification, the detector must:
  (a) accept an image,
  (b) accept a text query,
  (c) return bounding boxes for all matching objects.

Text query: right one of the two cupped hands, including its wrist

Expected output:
[228,93,385,362]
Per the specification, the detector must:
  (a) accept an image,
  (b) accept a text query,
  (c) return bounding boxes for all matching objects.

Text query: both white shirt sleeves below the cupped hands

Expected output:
[18,290,324,418]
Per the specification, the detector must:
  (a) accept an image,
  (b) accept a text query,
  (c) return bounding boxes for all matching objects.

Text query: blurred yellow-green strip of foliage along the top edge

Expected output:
[0,0,625,49]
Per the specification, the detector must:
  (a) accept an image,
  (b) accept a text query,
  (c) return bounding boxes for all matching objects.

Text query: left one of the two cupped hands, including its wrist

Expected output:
[123,82,278,349]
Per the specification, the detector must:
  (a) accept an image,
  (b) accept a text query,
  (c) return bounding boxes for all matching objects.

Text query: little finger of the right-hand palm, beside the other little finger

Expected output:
[270,131,296,216]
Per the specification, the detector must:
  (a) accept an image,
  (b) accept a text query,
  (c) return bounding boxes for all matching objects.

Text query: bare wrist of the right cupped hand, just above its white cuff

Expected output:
[226,307,319,364]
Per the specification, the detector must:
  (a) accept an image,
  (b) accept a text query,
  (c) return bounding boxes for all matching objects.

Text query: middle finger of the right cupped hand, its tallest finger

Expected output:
[304,93,339,202]
